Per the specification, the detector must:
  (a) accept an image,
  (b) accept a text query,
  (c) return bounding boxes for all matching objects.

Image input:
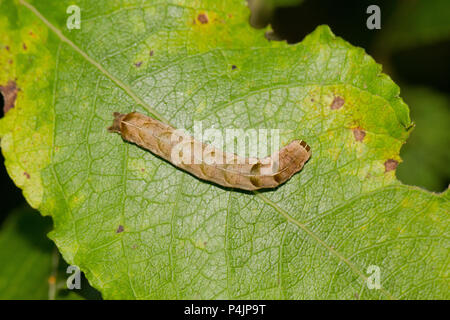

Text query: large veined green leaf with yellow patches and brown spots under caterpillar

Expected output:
[0,0,450,299]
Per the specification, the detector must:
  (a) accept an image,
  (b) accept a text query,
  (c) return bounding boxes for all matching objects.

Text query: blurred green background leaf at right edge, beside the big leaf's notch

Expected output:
[397,87,450,191]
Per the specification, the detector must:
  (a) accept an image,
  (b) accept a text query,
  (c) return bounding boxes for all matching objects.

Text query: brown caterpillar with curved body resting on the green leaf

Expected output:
[108,112,311,190]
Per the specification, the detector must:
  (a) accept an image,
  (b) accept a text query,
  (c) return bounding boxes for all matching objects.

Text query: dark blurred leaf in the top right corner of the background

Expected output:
[374,0,450,91]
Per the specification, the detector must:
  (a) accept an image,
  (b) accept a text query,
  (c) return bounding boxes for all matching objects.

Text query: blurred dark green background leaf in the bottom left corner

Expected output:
[0,206,99,300]
